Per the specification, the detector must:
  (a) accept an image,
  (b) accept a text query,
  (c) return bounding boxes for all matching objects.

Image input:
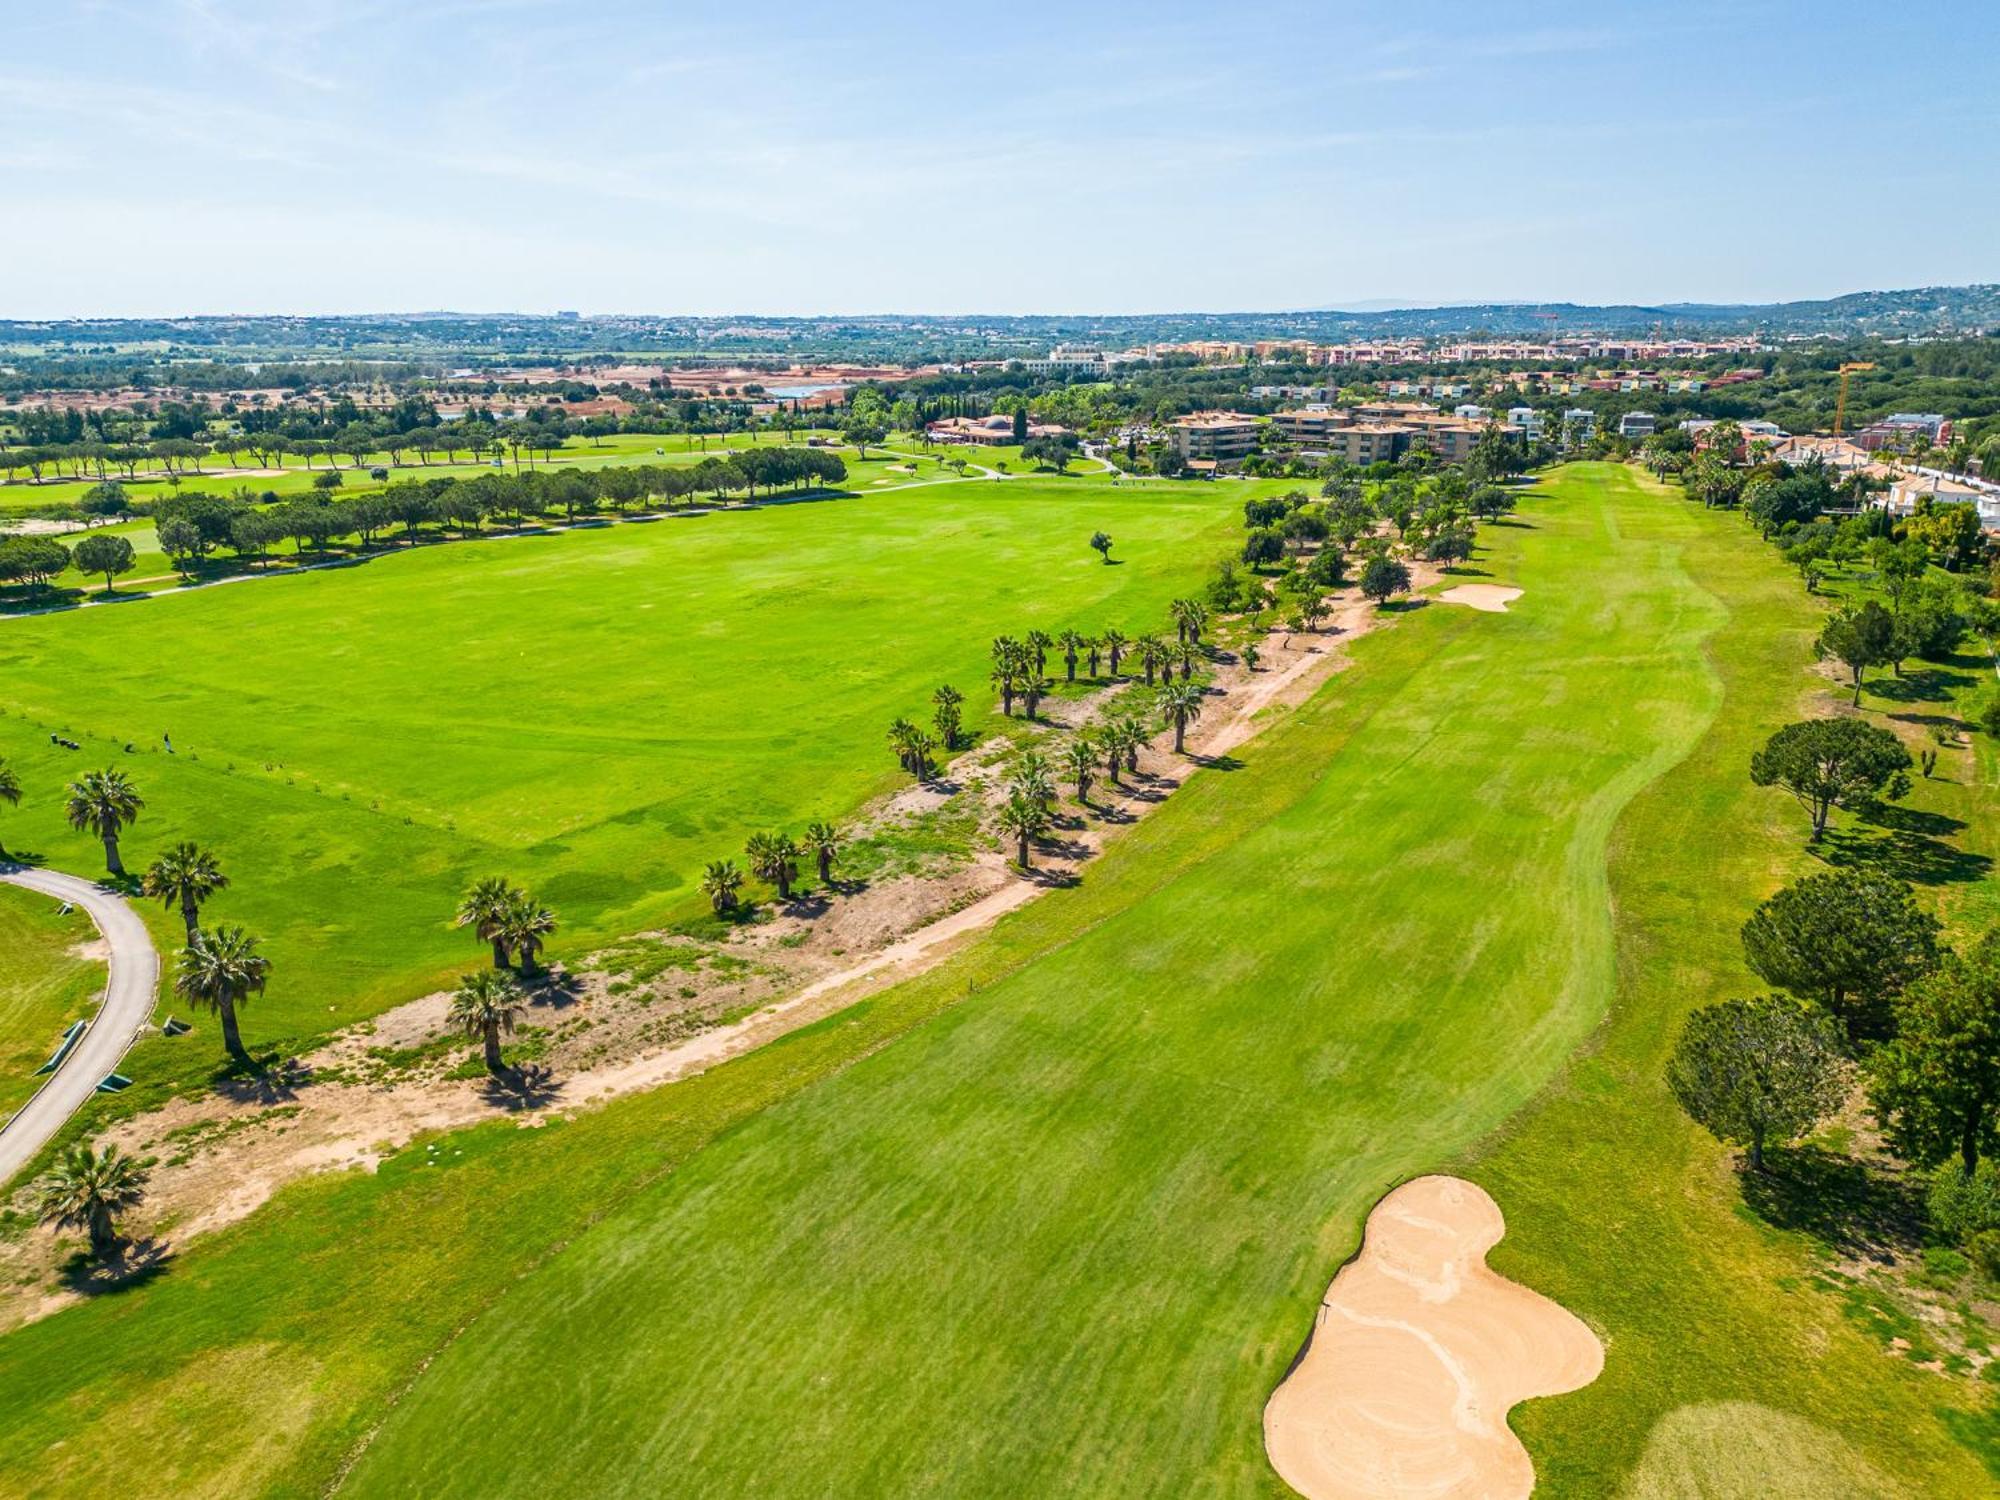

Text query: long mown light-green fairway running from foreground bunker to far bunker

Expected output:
[348,464,1752,1496]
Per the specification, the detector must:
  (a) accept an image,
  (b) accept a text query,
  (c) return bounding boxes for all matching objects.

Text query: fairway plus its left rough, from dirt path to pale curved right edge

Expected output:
[0,464,1720,1494]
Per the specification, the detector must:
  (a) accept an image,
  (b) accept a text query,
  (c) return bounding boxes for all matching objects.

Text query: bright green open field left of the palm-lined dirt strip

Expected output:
[0,482,1236,1078]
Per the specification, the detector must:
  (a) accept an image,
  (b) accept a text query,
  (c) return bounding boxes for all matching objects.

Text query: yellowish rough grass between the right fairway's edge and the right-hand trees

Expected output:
[1464,468,2000,1496]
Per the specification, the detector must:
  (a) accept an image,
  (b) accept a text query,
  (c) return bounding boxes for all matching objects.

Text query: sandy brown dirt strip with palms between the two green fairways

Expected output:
[0,570,1434,1326]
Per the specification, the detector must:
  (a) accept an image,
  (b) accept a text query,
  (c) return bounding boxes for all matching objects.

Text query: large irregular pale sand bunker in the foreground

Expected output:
[1264,1184,1604,1500]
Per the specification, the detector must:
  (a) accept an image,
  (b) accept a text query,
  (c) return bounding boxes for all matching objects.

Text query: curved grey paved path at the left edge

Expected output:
[0,864,160,1184]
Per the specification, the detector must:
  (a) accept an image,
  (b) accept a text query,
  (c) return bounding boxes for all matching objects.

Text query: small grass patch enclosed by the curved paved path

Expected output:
[0,886,104,1122]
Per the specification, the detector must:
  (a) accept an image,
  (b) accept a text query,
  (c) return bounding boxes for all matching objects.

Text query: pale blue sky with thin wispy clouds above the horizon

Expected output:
[0,0,2000,316]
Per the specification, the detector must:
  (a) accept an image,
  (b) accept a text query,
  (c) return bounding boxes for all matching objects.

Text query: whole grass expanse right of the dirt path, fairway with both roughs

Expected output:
[0,464,1992,1498]
